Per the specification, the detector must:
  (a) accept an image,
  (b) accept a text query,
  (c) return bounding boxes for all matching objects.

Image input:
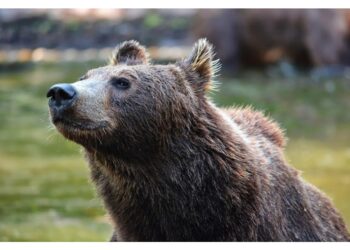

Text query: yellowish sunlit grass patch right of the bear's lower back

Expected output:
[287,138,350,225]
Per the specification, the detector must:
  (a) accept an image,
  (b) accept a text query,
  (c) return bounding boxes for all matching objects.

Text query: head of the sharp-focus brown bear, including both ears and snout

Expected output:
[47,39,218,159]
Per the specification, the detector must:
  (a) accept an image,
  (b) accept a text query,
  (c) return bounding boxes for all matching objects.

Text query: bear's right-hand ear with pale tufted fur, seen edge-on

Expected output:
[185,38,220,91]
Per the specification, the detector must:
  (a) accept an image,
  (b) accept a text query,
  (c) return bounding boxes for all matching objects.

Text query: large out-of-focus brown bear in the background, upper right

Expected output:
[192,9,350,69]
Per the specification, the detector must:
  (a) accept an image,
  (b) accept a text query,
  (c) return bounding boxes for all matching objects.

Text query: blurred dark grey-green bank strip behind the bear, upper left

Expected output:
[0,10,193,48]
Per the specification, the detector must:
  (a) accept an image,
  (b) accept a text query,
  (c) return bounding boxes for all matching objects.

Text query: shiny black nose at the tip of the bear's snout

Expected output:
[46,83,77,107]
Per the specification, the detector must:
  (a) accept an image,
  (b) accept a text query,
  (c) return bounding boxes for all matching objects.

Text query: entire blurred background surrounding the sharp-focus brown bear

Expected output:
[0,9,350,241]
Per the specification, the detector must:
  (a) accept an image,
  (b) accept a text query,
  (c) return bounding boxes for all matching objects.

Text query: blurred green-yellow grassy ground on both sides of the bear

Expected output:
[0,64,350,241]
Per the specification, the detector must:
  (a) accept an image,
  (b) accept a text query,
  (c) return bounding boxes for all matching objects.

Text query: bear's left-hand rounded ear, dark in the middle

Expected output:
[110,40,148,65]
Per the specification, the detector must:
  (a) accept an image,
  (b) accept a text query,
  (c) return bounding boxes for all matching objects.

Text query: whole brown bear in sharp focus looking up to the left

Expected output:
[47,39,350,241]
